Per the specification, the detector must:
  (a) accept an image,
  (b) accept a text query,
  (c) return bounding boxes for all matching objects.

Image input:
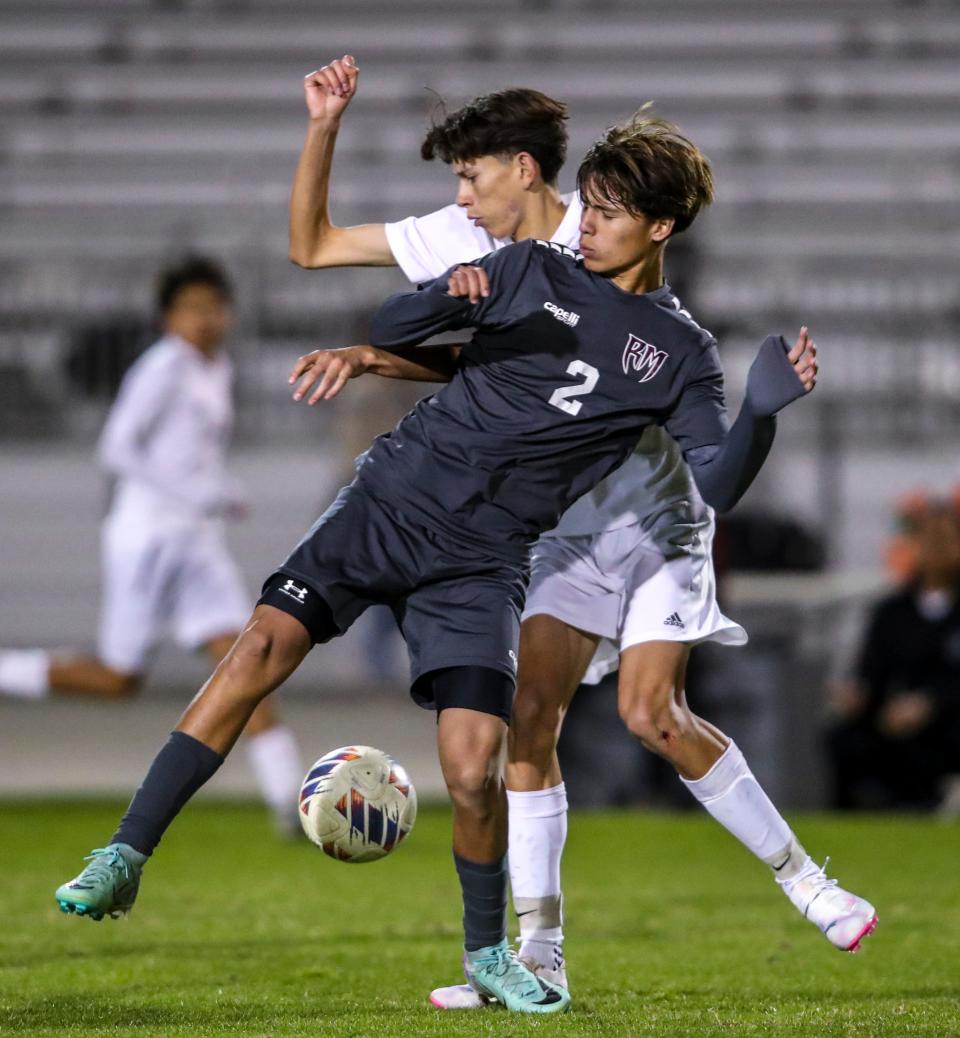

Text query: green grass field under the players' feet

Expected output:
[0,802,960,1038]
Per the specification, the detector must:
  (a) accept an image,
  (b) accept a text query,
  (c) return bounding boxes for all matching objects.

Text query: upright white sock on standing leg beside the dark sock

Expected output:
[506,783,567,951]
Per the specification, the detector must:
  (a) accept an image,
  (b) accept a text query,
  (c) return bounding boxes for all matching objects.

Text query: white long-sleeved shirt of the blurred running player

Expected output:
[99,335,241,525]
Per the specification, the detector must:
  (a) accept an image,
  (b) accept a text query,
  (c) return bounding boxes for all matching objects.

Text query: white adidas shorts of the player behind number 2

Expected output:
[523,523,747,684]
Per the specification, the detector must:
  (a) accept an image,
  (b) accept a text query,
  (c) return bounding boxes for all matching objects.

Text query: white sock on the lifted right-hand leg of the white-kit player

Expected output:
[681,740,806,880]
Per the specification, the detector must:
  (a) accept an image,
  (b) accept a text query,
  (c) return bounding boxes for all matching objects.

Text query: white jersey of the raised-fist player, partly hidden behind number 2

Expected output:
[385,192,713,554]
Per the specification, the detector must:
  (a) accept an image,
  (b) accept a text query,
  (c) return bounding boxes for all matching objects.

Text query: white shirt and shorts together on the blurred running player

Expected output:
[98,335,250,674]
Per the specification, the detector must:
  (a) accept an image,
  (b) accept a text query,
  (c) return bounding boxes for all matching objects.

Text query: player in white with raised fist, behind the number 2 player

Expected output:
[290,55,874,1008]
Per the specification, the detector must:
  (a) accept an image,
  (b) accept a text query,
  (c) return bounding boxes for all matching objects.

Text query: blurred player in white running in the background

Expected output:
[0,256,302,836]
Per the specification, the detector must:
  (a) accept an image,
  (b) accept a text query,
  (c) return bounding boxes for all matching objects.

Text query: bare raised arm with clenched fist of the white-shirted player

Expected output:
[290,54,395,268]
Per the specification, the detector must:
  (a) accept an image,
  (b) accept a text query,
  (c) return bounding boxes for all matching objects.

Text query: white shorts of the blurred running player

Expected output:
[99,515,253,674]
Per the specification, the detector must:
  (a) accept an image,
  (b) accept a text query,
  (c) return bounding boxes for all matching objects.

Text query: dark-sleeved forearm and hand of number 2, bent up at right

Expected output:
[666,327,819,512]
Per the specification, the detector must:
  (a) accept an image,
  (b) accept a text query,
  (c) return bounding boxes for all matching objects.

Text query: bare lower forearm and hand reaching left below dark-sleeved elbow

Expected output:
[287,346,460,406]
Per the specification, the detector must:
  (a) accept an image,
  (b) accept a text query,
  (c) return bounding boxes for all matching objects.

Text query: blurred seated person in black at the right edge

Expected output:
[828,498,960,809]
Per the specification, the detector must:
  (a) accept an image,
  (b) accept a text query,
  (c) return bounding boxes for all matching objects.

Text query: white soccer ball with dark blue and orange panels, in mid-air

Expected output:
[300,746,416,863]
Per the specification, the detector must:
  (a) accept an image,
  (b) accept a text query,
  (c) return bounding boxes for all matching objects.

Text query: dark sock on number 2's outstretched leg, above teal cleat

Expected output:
[110,732,223,854]
